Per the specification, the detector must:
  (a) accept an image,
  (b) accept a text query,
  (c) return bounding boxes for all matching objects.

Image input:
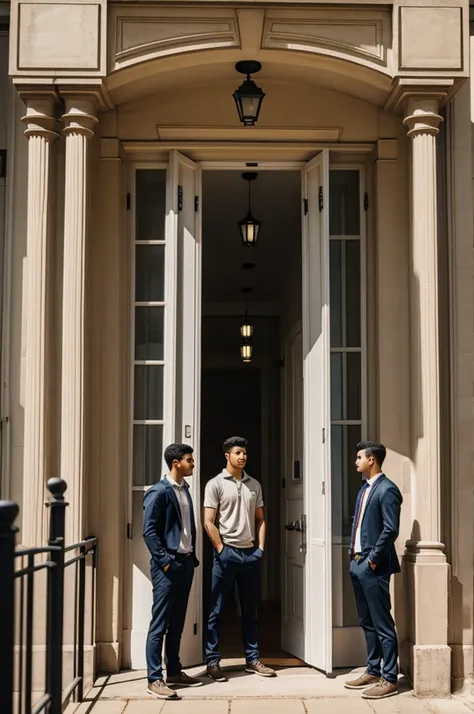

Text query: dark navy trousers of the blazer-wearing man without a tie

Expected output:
[146,555,194,682]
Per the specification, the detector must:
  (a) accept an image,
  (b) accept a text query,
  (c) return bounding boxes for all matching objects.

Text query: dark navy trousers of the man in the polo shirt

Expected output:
[206,545,262,664]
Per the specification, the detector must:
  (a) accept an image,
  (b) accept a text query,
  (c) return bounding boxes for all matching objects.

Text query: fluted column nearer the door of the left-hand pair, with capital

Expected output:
[61,97,97,543]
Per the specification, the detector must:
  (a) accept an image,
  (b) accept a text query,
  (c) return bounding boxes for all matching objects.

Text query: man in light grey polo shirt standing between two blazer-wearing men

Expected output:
[204,436,275,682]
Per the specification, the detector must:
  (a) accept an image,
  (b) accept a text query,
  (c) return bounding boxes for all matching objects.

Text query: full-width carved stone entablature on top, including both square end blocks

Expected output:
[10,0,469,96]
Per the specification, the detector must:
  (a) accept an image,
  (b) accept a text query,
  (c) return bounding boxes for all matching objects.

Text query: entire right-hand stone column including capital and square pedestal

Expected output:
[402,92,451,696]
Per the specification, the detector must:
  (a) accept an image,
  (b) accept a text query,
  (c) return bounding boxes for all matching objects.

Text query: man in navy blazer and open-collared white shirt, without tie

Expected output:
[143,444,203,699]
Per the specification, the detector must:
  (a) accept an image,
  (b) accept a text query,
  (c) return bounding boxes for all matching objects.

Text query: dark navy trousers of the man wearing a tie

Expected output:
[350,558,398,684]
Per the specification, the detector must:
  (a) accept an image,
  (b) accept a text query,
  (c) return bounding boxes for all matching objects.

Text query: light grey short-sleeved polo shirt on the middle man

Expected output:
[204,469,263,548]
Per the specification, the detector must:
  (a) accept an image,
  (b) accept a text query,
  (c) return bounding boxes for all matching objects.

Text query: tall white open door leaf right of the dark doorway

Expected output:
[302,150,332,672]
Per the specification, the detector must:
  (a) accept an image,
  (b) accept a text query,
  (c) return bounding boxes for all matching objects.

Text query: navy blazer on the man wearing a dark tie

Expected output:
[351,474,403,575]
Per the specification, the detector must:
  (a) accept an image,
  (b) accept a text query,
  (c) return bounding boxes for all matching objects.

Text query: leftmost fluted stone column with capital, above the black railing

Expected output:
[21,96,58,545]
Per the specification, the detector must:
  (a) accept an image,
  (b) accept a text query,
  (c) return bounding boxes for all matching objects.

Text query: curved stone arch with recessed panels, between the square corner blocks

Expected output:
[107,4,392,103]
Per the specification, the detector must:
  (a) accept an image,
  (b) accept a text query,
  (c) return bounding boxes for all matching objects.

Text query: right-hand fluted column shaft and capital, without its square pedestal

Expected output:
[404,97,444,551]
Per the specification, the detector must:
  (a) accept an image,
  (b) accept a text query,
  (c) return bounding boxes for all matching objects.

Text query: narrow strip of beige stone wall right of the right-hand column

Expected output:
[445,78,474,688]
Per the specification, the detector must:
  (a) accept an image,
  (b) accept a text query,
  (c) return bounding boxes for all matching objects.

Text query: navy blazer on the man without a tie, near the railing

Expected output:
[143,478,199,568]
